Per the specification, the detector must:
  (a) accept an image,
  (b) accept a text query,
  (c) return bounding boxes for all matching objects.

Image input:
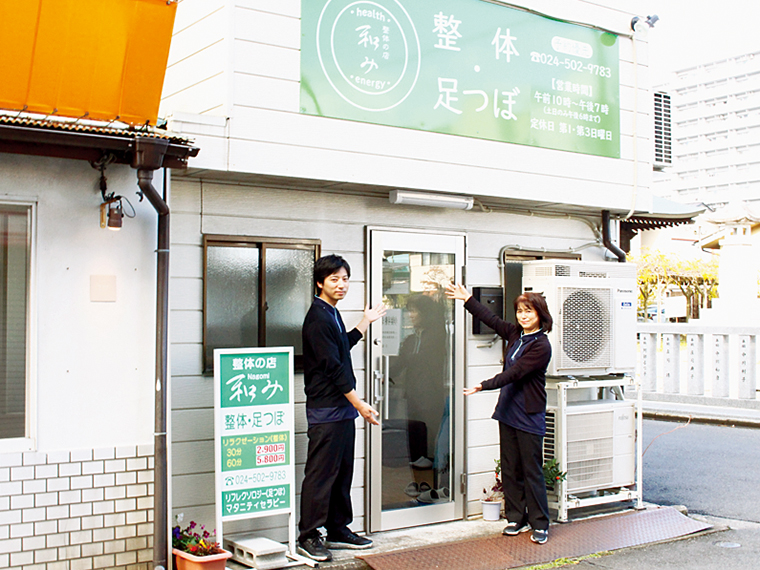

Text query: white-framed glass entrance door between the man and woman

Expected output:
[368,229,464,531]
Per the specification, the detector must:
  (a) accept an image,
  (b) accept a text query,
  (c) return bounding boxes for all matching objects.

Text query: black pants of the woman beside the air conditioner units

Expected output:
[499,422,549,530]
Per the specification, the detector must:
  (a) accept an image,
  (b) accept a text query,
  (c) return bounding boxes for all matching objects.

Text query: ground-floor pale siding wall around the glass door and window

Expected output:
[170,176,603,528]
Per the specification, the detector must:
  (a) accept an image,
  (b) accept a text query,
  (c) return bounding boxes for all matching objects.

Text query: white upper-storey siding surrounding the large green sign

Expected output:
[162,0,653,212]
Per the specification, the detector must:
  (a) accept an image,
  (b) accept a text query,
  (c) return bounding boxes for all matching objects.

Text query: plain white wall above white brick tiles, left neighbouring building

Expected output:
[0,153,161,453]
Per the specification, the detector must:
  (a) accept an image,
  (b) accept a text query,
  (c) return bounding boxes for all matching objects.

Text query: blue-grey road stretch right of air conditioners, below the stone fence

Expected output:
[643,414,760,522]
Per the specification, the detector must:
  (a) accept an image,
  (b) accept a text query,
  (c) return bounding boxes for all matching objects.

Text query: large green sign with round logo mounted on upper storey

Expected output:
[301,0,620,158]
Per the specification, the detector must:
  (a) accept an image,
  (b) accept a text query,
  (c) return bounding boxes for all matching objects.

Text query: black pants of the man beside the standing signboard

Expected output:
[298,414,356,541]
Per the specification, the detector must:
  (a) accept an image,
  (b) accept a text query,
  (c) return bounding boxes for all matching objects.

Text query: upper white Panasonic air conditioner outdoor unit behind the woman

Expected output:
[522,259,637,376]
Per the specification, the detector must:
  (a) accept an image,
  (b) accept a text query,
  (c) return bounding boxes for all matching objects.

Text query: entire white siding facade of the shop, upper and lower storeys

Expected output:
[162,0,653,528]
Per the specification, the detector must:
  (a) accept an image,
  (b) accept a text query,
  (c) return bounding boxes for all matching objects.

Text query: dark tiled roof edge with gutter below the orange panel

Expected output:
[0,113,199,168]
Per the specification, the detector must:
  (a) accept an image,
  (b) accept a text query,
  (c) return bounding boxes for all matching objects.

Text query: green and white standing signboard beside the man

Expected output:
[214,347,295,520]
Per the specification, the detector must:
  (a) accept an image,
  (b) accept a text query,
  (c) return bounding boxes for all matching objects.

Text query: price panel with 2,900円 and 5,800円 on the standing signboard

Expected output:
[222,432,290,471]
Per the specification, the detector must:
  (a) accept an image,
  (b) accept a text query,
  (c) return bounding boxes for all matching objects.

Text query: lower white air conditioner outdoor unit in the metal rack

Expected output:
[544,400,636,494]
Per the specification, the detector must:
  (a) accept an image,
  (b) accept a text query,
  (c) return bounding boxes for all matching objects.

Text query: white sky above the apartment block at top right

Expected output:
[631,0,760,85]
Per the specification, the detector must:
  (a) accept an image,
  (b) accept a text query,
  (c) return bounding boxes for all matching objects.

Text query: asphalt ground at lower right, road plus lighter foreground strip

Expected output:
[572,420,760,570]
